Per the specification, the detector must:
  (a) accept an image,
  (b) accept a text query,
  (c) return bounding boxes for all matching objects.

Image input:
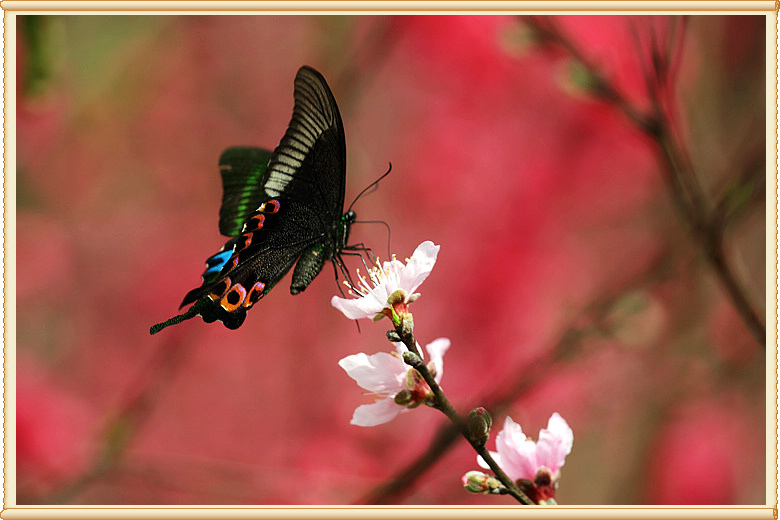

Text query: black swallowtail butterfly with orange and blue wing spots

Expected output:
[150,66,362,334]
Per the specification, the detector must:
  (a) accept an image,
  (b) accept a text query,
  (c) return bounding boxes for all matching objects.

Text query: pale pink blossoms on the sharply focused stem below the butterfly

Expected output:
[331,241,574,504]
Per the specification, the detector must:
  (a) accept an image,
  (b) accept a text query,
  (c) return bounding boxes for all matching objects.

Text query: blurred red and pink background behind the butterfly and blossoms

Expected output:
[16,16,767,505]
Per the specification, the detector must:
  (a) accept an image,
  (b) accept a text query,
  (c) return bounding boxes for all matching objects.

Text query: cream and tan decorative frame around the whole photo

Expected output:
[0,0,780,519]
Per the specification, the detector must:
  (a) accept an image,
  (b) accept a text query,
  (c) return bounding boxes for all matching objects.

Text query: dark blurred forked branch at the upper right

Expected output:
[521,16,766,347]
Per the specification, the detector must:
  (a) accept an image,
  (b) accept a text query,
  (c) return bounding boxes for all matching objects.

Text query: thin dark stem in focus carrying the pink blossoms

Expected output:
[396,325,534,505]
